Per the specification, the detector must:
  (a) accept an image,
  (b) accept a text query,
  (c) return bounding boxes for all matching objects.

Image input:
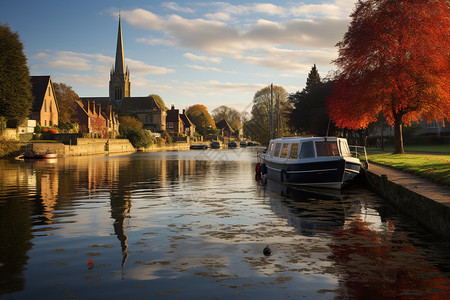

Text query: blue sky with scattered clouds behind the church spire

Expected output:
[0,0,355,112]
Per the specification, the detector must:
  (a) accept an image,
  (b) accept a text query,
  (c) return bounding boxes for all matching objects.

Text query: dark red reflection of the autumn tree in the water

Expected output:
[330,220,450,299]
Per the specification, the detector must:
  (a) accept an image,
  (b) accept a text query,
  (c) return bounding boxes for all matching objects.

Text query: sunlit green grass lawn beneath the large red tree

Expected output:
[368,154,450,186]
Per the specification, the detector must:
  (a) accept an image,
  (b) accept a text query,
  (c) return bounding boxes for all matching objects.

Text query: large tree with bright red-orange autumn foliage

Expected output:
[328,0,450,153]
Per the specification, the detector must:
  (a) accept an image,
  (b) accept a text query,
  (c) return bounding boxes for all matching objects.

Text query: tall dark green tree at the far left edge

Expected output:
[0,24,34,127]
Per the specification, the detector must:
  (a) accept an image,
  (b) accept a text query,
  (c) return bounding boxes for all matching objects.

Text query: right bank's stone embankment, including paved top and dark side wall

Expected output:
[361,164,450,240]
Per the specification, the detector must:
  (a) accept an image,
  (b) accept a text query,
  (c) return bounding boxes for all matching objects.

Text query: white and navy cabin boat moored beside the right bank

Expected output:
[258,137,361,189]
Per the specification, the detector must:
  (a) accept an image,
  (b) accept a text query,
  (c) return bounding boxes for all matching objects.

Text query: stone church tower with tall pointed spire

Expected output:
[109,15,131,100]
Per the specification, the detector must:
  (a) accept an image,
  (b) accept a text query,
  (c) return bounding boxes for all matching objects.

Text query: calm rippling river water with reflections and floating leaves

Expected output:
[0,148,450,299]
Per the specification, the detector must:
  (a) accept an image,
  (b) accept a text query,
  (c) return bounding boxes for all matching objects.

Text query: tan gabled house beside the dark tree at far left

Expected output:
[30,76,59,127]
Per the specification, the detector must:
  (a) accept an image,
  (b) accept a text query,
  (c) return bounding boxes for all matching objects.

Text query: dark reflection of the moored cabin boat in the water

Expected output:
[265,181,355,236]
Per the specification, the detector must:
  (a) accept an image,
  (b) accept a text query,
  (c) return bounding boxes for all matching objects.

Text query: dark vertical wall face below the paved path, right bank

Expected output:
[361,170,450,240]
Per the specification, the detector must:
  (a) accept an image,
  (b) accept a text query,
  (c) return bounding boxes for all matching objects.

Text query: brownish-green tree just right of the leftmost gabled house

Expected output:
[53,82,80,125]
